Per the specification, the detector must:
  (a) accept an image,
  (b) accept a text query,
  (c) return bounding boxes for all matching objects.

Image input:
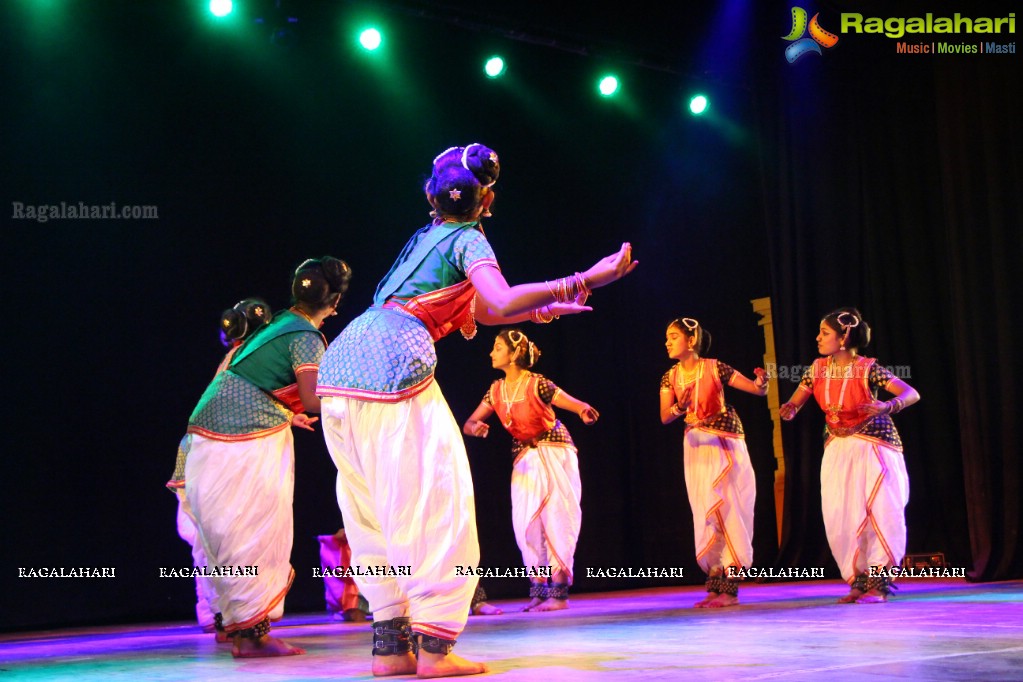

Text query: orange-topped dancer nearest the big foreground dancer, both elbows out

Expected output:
[462,329,599,611]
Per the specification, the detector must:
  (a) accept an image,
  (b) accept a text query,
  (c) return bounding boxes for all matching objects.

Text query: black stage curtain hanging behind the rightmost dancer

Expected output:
[758,2,1023,580]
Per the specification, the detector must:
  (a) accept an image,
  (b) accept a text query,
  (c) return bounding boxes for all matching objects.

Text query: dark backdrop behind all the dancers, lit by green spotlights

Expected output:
[0,2,1023,629]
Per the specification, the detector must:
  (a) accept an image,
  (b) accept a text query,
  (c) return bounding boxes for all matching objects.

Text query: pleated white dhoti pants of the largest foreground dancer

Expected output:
[321,381,480,639]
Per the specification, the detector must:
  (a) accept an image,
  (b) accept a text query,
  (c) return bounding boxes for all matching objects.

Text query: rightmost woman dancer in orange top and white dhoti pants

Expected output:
[781,308,920,603]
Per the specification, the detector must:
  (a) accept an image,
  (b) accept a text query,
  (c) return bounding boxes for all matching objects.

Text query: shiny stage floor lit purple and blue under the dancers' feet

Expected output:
[0,579,1023,682]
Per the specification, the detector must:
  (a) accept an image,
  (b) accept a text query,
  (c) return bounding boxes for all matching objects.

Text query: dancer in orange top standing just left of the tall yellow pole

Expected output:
[661,317,768,608]
